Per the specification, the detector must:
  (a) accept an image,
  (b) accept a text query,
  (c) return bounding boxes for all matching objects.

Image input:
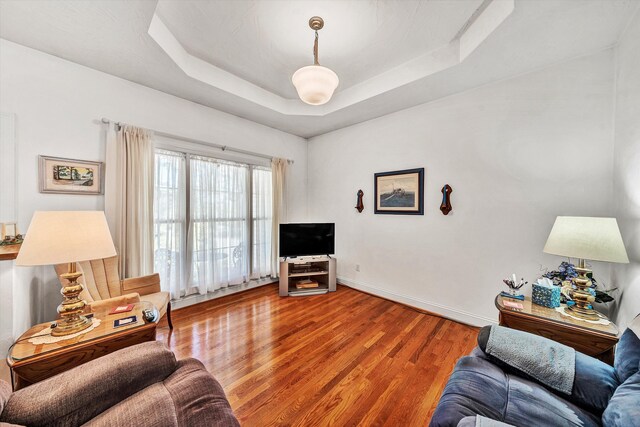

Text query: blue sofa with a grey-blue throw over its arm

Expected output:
[430,316,640,427]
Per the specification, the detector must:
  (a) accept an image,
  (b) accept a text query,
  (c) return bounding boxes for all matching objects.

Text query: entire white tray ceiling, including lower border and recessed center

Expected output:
[0,0,640,137]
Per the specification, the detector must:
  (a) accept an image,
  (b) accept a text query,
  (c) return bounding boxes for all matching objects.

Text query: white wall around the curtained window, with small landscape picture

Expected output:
[0,40,307,354]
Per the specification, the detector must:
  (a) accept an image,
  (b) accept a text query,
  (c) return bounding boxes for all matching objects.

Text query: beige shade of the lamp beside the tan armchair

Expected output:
[16,211,116,266]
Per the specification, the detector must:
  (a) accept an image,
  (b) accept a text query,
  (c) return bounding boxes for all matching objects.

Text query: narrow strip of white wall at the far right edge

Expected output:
[613,13,640,326]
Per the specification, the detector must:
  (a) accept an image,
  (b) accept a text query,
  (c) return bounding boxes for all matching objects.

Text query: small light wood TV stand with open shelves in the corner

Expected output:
[279,255,336,297]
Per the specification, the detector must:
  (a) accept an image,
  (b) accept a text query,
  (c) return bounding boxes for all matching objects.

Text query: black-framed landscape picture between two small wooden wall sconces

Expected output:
[374,168,424,215]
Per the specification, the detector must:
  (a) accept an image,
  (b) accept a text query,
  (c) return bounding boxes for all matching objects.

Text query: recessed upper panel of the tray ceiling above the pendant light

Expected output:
[157,0,482,98]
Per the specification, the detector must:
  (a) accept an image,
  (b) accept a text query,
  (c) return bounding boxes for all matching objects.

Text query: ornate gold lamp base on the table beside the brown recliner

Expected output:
[51,262,91,337]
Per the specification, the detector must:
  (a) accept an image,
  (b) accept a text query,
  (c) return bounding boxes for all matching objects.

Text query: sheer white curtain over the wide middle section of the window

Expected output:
[188,156,249,294]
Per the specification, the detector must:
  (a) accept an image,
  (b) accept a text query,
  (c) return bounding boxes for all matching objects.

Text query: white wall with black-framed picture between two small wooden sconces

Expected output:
[308,50,614,324]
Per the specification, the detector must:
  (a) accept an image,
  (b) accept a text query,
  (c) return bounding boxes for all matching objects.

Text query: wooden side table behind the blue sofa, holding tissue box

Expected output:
[495,295,618,365]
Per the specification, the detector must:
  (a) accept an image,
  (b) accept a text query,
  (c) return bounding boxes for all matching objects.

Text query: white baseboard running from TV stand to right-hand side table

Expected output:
[338,277,498,327]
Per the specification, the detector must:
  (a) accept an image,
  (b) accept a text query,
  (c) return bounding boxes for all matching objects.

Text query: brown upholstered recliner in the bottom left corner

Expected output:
[0,342,239,427]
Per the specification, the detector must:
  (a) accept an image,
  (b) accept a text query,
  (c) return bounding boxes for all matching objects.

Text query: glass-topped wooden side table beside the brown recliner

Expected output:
[7,301,160,391]
